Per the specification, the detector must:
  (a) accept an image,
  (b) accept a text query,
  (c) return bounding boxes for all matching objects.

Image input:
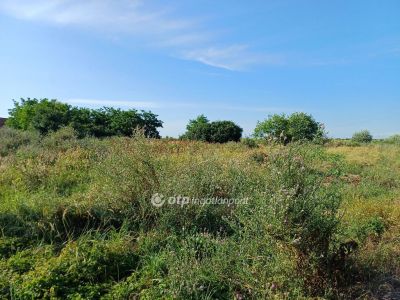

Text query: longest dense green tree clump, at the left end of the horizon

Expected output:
[6,98,163,138]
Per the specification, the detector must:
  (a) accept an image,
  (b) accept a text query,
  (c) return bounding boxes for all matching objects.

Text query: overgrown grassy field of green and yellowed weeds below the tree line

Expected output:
[0,128,400,300]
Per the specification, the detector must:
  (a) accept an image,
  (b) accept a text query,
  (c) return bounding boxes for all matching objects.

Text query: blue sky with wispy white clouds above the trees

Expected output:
[0,0,400,137]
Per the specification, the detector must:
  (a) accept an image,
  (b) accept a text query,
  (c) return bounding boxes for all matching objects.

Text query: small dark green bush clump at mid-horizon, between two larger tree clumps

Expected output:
[181,115,243,143]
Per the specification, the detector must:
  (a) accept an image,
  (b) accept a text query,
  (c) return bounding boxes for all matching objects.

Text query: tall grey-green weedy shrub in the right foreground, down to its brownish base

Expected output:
[238,148,341,295]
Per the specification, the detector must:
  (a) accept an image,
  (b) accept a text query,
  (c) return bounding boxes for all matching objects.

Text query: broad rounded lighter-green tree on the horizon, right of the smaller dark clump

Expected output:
[254,113,325,144]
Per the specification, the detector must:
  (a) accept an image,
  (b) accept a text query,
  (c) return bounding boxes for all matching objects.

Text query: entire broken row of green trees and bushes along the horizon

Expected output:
[6,98,378,144]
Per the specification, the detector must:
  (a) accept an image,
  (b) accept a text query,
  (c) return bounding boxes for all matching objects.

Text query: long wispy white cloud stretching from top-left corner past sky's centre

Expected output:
[0,0,272,70]
